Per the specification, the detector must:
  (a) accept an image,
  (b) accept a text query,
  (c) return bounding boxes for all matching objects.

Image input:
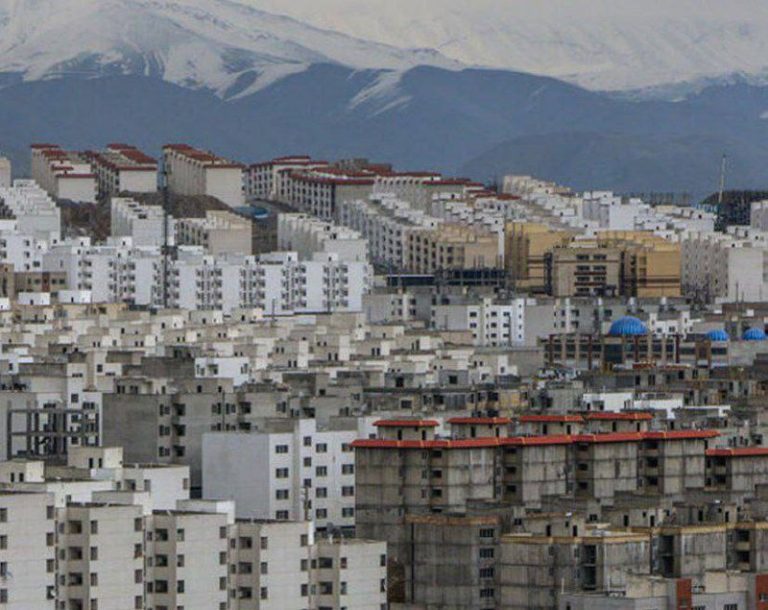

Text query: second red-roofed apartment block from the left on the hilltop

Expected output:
[87,144,157,196]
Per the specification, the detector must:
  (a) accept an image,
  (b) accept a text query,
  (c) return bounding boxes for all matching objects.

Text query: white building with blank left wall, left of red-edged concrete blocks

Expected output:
[203,419,373,529]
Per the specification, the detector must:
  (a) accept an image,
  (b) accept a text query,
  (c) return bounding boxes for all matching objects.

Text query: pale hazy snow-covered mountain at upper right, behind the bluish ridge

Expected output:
[246,0,768,90]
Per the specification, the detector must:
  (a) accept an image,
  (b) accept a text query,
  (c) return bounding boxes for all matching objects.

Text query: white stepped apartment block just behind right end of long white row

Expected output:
[277,214,368,262]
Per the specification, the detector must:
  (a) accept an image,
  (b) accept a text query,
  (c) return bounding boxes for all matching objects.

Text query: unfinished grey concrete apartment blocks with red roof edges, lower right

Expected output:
[353,413,768,610]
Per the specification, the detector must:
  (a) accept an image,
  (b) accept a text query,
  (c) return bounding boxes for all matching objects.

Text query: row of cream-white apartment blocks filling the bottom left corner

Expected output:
[0,447,387,610]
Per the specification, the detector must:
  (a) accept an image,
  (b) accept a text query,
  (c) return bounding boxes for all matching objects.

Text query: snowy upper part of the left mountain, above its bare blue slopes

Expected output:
[0,0,457,97]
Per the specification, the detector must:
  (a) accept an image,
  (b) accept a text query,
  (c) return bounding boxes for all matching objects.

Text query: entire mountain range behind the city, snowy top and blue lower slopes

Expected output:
[0,0,768,195]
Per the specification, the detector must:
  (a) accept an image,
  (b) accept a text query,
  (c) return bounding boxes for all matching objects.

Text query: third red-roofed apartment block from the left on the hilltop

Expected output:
[163,144,245,208]
